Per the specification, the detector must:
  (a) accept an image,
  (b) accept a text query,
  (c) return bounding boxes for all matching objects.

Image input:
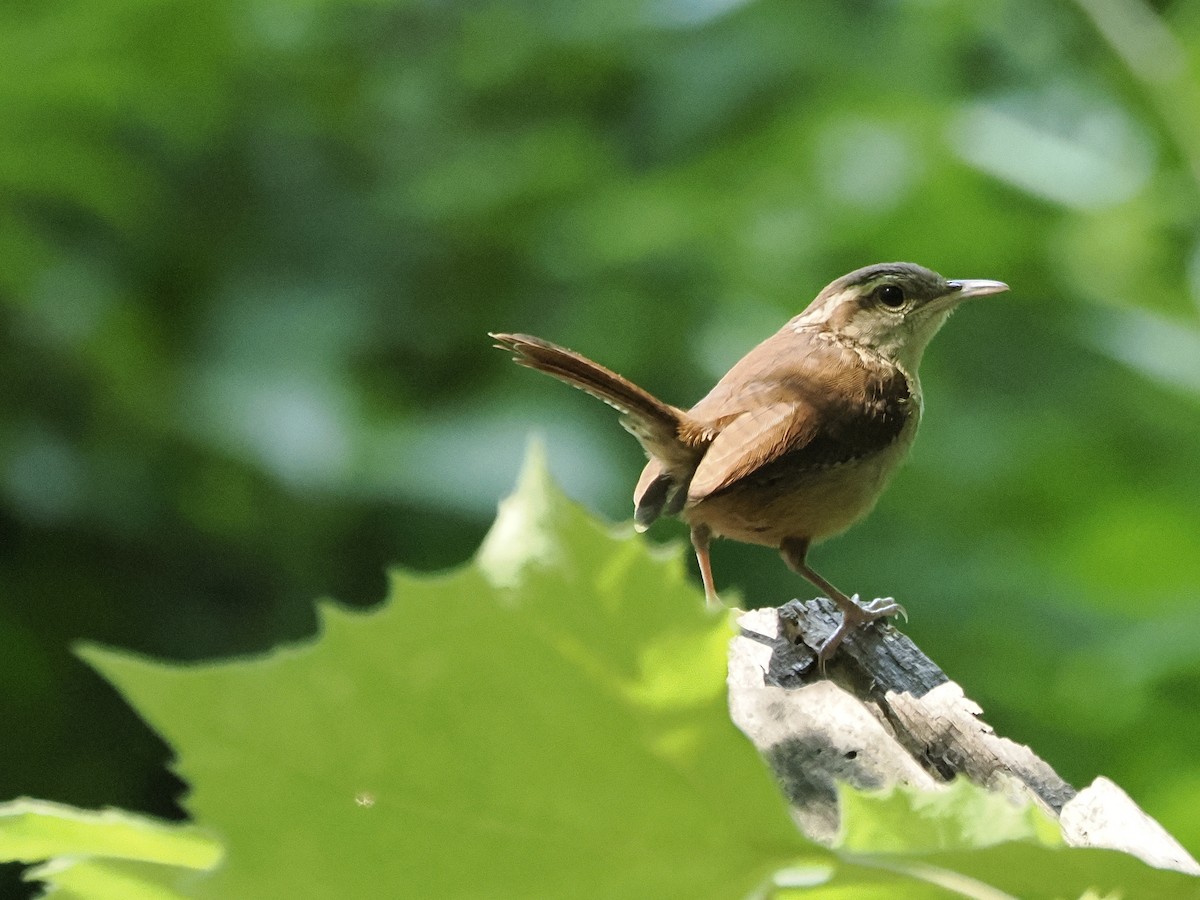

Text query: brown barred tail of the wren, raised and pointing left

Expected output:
[488,334,697,468]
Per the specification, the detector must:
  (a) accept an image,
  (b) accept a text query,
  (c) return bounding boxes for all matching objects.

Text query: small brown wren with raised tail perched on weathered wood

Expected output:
[491,263,1008,667]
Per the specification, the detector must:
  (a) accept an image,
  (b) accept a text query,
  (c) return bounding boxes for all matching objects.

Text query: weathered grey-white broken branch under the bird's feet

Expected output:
[730,600,1200,875]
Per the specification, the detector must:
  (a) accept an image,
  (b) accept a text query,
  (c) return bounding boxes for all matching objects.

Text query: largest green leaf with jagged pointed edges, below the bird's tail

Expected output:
[84,454,828,898]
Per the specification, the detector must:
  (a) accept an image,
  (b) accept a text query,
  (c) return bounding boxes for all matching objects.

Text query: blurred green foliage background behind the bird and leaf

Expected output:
[0,0,1200,888]
